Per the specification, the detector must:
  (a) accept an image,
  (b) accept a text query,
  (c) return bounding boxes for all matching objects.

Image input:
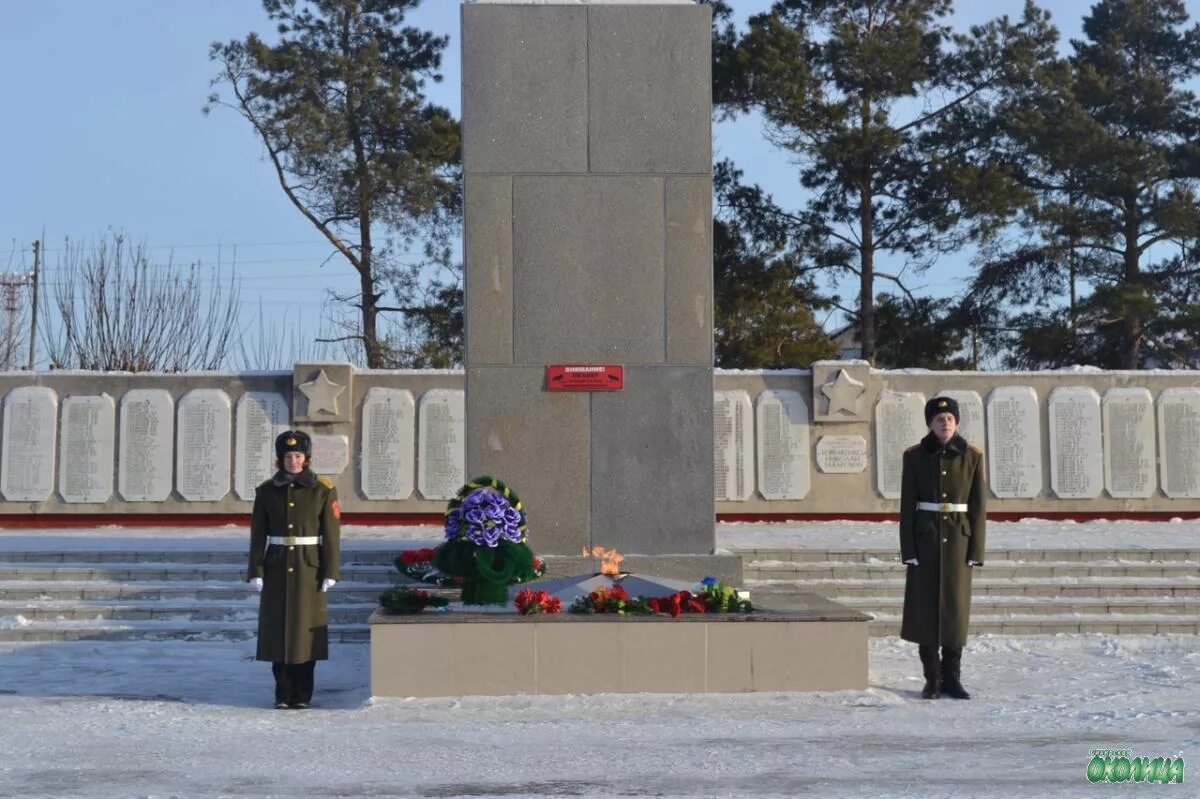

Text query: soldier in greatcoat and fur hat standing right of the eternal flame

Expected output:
[900,397,988,699]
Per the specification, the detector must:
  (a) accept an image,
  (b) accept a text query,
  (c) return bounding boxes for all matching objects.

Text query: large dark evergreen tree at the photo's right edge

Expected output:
[976,0,1200,368]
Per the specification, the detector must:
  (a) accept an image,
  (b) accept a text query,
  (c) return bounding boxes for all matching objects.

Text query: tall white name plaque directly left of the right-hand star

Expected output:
[755,389,812,499]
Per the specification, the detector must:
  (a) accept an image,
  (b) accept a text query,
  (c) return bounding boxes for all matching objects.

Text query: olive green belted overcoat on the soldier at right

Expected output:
[900,433,988,647]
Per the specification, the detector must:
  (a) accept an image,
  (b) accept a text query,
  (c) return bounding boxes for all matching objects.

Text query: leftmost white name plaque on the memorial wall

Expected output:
[0,386,59,503]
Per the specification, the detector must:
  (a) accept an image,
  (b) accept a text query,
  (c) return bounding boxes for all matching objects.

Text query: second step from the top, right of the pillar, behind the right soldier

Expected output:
[743,560,1200,581]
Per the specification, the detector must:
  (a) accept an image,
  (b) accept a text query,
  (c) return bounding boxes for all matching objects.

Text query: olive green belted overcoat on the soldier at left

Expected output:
[247,469,342,663]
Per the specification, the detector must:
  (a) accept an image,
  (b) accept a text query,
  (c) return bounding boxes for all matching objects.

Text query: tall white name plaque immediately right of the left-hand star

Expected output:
[359,386,416,499]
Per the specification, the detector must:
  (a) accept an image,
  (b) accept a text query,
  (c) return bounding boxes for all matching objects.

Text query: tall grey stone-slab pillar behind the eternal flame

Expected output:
[462,0,714,554]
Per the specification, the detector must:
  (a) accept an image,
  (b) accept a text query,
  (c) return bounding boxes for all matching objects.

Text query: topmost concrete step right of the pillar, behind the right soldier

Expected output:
[730,541,1200,565]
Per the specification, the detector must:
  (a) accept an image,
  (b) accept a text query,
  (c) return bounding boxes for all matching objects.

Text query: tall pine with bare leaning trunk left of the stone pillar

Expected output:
[205,0,461,368]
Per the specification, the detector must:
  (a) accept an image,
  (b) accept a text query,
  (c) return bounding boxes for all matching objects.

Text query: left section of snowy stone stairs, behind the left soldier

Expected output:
[0,549,400,642]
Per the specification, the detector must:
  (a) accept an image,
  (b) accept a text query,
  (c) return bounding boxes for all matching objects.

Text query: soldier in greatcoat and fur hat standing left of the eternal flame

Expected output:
[247,429,342,708]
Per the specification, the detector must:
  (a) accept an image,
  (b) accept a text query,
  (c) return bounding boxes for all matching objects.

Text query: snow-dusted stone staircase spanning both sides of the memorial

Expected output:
[0,542,1200,642]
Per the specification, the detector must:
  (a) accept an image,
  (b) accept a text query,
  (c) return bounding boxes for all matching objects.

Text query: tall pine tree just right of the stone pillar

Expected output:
[714,0,1039,362]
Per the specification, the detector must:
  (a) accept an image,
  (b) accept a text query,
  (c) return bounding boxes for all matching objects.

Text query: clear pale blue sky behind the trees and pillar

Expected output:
[0,0,1091,364]
